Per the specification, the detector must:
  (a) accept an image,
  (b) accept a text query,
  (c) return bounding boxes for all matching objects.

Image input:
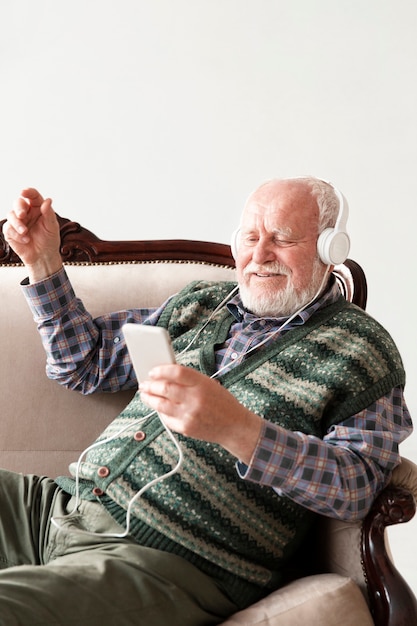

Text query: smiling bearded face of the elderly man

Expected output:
[236,181,326,317]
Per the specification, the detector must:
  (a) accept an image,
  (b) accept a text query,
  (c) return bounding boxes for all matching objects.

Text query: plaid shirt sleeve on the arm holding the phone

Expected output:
[237,387,413,521]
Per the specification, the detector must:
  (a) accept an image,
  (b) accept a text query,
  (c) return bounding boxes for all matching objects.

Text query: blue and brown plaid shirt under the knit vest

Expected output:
[23,270,412,520]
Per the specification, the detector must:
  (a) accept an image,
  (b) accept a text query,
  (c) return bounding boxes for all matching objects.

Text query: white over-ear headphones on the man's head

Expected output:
[230,181,350,265]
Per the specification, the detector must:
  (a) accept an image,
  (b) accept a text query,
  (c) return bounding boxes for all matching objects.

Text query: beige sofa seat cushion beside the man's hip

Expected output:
[219,574,374,626]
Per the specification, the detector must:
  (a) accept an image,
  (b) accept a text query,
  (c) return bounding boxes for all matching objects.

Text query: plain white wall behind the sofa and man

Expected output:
[0,0,417,592]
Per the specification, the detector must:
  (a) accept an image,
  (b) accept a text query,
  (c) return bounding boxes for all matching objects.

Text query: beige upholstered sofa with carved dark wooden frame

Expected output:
[0,218,417,626]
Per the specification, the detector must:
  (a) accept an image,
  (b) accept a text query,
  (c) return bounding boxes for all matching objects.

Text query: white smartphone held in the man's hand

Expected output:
[122,323,175,382]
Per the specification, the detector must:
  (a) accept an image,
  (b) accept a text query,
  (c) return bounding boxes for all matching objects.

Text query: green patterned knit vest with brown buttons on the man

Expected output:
[58,283,405,606]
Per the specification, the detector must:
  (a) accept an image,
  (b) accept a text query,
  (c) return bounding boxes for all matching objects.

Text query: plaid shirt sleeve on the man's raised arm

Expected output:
[22,269,163,394]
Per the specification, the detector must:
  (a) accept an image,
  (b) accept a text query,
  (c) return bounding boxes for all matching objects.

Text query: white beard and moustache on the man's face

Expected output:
[239,258,324,317]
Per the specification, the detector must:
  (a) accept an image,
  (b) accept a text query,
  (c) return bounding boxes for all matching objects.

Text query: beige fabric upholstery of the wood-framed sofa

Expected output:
[0,262,417,626]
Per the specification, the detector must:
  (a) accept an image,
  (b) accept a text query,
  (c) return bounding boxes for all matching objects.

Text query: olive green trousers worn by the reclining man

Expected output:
[0,470,237,626]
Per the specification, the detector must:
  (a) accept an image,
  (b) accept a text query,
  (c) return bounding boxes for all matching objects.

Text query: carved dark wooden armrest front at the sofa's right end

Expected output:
[361,485,417,626]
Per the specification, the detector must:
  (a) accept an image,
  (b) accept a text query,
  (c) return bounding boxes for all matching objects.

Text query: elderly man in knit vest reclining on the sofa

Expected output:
[0,178,412,626]
